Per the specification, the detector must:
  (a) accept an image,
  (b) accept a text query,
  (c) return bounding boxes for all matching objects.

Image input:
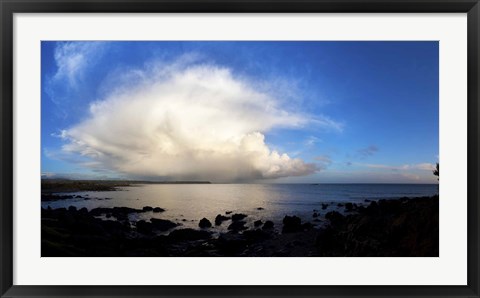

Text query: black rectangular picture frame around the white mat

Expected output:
[0,0,480,297]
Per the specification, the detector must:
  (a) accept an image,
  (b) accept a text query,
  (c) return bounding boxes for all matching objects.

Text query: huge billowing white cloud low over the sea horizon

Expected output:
[61,65,326,182]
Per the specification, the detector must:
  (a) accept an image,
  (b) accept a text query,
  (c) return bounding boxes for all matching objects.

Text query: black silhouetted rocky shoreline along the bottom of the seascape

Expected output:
[41,196,439,257]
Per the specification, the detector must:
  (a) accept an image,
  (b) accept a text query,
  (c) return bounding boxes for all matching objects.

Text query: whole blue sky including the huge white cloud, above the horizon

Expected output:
[41,41,439,183]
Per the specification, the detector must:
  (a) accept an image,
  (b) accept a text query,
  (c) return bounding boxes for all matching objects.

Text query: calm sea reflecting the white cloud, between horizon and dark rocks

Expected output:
[42,184,439,232]
